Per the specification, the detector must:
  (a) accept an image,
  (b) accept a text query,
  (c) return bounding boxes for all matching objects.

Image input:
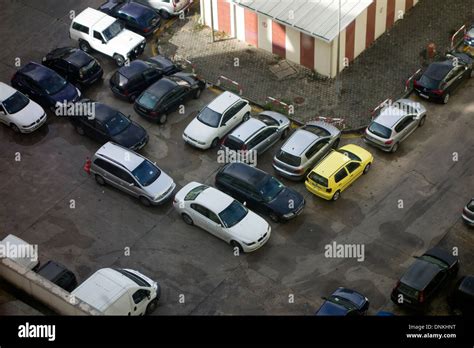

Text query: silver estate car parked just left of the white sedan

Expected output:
[90,142,176,206]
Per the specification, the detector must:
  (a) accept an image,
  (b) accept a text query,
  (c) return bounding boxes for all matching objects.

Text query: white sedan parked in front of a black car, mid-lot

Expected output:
[173,182,271,252]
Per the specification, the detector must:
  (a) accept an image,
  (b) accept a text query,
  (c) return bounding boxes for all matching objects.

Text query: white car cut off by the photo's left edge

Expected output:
[0,82,46,133]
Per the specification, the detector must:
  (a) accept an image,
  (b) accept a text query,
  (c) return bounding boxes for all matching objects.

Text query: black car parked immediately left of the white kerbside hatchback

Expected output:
[133,73,206,124]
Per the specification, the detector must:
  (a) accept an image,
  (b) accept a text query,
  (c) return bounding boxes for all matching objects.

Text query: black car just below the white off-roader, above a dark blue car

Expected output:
[43,47,104,87]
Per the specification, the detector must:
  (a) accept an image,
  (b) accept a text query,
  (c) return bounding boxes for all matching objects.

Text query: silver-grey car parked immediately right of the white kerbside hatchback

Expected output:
[222,111,290,154]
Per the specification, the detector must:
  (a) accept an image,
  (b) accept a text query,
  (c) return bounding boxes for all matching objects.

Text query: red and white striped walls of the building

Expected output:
[201,0,418,77]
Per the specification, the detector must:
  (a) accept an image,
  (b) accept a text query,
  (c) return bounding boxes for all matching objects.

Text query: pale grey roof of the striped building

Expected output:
[232,0,373,42]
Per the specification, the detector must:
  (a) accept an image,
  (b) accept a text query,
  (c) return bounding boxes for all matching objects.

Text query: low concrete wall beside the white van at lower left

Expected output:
[0,258,102,315]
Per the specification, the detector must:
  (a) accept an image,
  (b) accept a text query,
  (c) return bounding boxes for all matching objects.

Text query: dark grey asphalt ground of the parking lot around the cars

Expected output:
[0,2,474,315]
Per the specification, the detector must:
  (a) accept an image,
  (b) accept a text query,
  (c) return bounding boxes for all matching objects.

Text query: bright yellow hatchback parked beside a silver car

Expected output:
[305,144,374,201]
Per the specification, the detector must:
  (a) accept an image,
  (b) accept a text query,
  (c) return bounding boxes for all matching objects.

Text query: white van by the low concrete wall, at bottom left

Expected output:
[71,268,160,315]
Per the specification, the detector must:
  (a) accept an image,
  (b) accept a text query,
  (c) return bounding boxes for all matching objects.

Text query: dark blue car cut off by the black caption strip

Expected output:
[316,287,370,316]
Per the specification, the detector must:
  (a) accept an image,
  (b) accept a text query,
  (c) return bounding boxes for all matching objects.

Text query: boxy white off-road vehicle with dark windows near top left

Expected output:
[69,7,146,66]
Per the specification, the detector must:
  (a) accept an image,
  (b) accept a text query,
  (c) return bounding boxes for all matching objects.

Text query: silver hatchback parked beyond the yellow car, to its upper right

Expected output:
[364,99,426,152]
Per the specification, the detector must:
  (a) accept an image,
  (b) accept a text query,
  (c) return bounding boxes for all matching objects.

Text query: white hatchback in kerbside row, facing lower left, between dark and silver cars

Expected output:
[183,92,251,150]
